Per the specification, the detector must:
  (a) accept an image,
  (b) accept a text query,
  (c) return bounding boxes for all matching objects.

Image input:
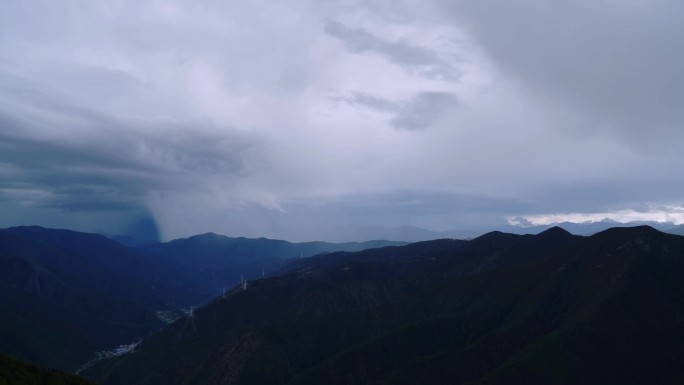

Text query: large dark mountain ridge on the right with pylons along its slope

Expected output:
[85,226,684,385]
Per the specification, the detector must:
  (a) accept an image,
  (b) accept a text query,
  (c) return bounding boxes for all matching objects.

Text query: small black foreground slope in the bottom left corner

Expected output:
[0,353,93,385]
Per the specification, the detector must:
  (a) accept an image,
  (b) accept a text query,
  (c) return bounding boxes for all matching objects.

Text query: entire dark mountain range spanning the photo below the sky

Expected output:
[0,226,684,385]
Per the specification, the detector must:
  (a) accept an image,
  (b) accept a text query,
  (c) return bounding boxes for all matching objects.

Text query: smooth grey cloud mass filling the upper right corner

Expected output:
[443,0,684,141]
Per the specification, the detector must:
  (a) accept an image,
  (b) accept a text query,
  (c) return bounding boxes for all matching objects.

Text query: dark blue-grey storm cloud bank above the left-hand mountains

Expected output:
[0,75,264,211]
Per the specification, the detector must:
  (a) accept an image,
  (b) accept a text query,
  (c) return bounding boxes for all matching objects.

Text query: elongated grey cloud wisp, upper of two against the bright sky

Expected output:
[325,21,460,81]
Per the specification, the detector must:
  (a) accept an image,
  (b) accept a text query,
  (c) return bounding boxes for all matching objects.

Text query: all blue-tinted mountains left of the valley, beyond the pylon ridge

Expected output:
[0,226,404,371]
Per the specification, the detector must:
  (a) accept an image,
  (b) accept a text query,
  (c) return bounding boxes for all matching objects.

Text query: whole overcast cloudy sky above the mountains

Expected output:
[0,0,684,241]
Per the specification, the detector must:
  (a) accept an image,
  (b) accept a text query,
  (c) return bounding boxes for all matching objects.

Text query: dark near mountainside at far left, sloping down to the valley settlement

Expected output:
[0,232,162,370]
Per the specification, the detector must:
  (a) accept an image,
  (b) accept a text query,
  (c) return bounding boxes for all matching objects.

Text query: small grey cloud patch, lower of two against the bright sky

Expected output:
[341,91,458,130]
